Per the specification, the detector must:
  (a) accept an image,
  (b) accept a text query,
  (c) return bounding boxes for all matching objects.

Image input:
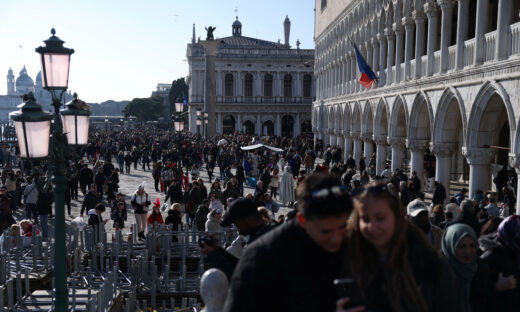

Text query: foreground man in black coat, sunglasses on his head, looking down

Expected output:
[224,174,353,312]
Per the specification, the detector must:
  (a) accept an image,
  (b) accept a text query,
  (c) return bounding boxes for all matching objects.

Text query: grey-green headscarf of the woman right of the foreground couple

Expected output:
[441,223,478,312]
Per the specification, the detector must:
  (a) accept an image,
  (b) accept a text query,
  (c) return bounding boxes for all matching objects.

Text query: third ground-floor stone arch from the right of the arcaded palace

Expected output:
[408,91,433,140]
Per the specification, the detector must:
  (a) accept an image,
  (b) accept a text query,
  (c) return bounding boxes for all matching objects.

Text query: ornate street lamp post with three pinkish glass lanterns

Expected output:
[10,28,90,312]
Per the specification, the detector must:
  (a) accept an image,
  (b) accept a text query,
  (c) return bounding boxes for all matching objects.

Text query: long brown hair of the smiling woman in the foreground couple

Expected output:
[347,183,428,311]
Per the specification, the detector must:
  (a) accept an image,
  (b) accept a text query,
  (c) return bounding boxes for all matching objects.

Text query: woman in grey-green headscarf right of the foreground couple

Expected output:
[442,223,495,312]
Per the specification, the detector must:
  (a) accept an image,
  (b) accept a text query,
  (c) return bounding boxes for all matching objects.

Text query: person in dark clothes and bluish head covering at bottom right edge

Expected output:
[479,215,520,312]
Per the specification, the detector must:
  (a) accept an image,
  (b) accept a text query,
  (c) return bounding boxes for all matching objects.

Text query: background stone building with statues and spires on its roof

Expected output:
[186,18,315,136]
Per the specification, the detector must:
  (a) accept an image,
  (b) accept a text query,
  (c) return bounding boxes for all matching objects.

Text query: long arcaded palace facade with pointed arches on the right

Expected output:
[312,0,520,210]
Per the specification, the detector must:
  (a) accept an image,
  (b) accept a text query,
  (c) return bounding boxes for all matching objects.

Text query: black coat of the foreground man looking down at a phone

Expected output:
[224,220,341,312]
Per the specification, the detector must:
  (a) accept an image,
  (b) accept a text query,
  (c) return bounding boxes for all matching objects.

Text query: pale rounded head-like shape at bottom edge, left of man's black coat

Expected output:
[200,269,229,312]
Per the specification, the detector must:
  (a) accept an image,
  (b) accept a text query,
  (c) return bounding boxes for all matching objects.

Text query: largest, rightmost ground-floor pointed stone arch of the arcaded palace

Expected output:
[466,81,516,147]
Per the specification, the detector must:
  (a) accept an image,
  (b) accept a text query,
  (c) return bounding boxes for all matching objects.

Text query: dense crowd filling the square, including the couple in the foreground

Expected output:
[0,126,520,312]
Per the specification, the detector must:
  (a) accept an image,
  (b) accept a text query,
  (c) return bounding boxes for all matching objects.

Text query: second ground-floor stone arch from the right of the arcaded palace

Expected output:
[433,87,468,146]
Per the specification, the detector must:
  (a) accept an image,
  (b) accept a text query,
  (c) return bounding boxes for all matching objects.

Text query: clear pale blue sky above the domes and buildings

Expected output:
[0,0,314,102]
